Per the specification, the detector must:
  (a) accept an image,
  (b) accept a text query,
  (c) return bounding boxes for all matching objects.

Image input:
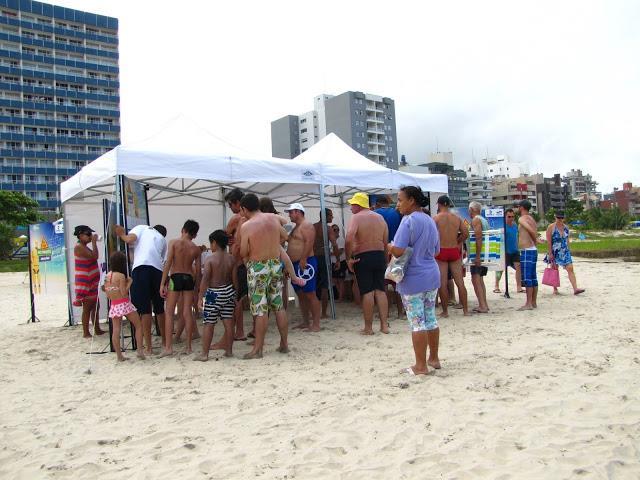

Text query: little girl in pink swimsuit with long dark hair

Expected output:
[103,252,145,362]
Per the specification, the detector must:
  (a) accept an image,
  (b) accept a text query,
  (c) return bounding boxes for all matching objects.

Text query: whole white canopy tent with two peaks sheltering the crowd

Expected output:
[60,117,448,322]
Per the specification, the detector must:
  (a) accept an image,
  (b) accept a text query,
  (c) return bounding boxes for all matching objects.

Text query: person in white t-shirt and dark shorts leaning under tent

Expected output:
[114,225,167,355]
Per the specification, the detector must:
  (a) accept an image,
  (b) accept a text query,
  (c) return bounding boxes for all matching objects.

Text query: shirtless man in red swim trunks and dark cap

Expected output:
[434,195,469,318]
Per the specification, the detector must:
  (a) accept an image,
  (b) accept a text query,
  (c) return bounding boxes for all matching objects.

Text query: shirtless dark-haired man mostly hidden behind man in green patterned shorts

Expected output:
[222,188,248,342]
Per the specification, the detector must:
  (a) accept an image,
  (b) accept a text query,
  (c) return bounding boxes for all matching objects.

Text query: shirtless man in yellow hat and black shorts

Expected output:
[345,192,389,335]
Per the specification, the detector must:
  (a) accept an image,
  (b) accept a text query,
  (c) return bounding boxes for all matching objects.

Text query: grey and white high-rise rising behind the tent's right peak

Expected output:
[271,91,398,169]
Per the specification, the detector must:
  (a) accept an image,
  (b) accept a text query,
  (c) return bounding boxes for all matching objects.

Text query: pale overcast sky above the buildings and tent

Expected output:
[54,0,640,192]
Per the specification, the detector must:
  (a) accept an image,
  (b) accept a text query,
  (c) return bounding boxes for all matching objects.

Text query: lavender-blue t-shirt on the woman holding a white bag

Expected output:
[393,212,440,295]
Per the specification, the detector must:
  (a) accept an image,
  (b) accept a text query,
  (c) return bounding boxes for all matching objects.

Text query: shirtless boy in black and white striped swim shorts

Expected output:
[194,230,237,362]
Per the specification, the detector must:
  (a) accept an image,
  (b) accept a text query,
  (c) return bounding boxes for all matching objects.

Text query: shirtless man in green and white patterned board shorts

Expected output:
[240,193,289,360]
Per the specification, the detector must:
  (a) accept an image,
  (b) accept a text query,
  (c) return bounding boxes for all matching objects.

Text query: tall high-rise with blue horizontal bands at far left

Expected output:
[0,0,120,212]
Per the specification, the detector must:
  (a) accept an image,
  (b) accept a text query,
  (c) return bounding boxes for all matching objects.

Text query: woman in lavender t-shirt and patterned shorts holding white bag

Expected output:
[387,186,440,375]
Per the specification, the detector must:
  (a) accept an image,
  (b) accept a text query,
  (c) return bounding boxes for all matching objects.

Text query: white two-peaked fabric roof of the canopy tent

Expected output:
[60,117,448,203]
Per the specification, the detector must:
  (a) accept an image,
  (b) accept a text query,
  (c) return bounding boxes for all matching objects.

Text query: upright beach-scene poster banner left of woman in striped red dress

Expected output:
[28,219,70,321]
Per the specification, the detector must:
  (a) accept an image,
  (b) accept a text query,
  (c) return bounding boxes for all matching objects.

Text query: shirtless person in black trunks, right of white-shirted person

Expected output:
[159,220,201,357]
